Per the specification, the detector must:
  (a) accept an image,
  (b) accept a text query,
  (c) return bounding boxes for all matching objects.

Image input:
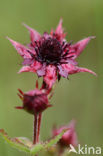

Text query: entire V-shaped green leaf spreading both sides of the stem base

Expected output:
[0,129,66,155]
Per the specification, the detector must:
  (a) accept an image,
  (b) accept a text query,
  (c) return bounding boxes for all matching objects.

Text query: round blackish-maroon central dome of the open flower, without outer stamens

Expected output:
[37,38,63,64]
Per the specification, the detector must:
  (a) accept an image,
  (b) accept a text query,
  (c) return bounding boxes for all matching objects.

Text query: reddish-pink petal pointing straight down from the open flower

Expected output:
[44,65,57,88]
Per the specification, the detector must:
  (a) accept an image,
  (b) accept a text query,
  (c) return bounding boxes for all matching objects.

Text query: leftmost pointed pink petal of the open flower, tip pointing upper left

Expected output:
[7,37,34,59]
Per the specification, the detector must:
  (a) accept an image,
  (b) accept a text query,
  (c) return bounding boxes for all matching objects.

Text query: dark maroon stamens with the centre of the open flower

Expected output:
[28,33,72,66]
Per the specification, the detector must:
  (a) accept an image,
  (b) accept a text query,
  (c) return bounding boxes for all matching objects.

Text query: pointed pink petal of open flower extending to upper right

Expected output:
[71,36,95,58]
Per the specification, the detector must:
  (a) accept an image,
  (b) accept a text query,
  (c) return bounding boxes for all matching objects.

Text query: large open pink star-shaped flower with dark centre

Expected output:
[8,20,96,88]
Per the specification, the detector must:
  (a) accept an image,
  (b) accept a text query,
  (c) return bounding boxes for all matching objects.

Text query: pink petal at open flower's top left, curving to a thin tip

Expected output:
[23,23,41,44]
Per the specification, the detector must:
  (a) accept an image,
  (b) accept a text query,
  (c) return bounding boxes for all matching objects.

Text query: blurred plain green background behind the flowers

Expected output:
[0,0,103,156]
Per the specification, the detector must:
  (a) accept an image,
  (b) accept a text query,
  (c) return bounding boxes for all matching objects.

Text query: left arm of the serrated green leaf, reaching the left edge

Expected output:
[0,129,30,153]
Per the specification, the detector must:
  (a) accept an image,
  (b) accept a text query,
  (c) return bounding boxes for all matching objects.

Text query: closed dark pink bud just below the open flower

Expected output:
[16,81,52,115]
